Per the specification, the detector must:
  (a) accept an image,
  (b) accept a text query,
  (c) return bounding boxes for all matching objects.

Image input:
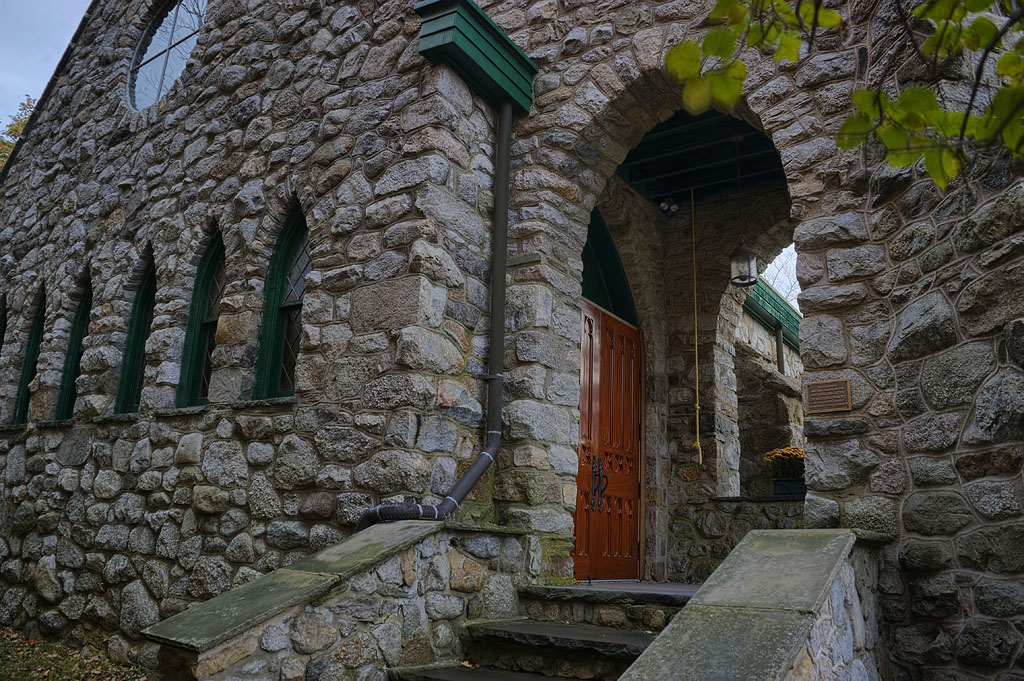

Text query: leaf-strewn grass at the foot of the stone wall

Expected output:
[0,629,146,681]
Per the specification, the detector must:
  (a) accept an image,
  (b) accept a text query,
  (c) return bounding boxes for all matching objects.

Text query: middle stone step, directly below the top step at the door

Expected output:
[466,620,654,658]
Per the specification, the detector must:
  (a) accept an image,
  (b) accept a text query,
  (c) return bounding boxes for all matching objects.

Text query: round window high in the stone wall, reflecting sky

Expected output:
[128,0,206,109]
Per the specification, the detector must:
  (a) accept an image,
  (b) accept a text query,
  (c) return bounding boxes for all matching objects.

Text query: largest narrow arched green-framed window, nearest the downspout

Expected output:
[253,209,312,399]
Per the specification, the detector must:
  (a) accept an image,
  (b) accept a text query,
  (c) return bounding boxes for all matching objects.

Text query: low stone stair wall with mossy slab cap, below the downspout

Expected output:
[145,521,540,681]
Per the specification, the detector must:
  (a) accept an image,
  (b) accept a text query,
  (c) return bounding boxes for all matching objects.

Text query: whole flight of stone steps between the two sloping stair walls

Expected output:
[390,582,698,681]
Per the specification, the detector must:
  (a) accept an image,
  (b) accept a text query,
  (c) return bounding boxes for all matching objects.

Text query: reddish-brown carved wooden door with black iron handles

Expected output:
[572,301,643,580]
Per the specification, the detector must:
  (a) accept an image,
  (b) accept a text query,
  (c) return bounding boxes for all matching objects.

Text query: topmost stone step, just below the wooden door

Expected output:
[519,582,699,631]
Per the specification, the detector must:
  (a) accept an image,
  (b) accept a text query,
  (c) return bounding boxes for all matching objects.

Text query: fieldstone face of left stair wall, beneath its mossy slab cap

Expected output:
[156,525,541,681]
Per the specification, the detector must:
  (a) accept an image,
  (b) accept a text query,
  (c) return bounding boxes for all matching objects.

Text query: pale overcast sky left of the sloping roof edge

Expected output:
[0,0,89,127]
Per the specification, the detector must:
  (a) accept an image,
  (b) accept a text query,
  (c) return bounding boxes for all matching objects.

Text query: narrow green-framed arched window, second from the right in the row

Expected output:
[176,232,225,407]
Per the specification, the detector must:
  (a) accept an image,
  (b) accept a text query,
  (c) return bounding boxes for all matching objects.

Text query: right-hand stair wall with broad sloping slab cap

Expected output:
[621,529,886,681]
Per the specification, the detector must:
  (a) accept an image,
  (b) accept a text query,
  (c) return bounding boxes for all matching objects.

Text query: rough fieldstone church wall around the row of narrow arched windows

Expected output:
[0,0,516,656]
